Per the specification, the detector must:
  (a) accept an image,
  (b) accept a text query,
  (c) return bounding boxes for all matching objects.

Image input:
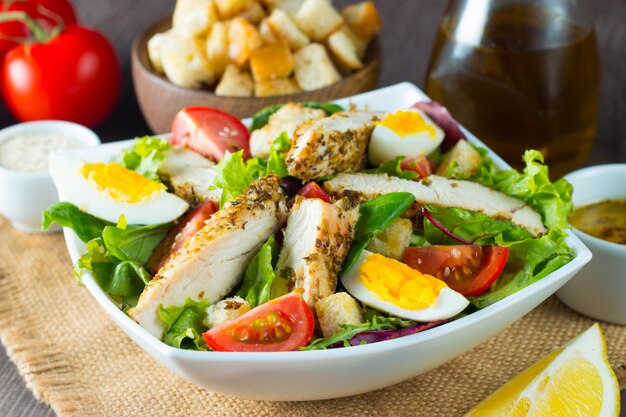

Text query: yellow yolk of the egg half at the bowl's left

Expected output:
[81,162,165,203]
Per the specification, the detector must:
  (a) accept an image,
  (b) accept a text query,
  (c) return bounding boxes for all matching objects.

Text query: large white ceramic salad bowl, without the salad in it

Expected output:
[56,83,591,401]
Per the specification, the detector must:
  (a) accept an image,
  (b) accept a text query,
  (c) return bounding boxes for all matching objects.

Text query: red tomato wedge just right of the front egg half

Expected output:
[404,245,509,297]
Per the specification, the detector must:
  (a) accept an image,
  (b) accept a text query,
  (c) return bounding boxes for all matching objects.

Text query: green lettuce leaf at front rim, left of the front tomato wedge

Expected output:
[159,298,210,350]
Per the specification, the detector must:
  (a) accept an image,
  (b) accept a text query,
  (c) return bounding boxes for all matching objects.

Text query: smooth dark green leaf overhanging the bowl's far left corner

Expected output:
[41,202,111,242]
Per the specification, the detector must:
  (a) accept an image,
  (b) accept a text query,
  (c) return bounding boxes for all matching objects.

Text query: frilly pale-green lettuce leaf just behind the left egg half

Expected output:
[115,136,172,181]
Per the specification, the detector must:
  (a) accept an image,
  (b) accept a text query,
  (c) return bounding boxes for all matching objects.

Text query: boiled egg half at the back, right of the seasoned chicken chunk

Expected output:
[368,109,445,166]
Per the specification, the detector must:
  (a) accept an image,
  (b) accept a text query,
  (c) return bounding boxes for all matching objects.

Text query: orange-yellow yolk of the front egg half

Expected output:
[359,253,447,310]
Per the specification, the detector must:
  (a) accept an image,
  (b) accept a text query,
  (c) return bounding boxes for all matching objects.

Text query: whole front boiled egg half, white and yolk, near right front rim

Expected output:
[341,251,469,322]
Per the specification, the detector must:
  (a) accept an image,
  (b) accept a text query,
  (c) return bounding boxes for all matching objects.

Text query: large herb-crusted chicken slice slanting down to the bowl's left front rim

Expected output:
[128,175,286,338]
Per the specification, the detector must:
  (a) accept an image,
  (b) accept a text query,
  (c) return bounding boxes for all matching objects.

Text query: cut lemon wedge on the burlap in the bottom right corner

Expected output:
[465,324,620,417]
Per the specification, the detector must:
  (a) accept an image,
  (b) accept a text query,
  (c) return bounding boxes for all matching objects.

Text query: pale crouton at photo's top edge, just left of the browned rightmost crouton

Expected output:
[295,0,343,42]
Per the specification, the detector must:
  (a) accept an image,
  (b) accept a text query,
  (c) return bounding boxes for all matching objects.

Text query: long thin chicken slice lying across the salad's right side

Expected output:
[324,174,548,236]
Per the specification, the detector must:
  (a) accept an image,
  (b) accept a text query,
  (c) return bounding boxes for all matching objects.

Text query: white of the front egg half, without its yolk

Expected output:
[341,250,469,322]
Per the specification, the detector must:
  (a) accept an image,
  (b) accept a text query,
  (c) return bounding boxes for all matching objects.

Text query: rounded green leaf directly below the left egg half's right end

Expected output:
[102,223,172,265]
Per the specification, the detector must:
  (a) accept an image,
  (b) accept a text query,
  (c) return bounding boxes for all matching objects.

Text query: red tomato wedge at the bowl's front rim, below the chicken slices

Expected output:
[202,292,315,352]
